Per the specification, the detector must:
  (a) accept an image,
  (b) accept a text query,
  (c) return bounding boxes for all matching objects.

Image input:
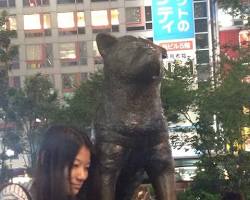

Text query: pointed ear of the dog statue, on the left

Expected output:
[96,33,117,57]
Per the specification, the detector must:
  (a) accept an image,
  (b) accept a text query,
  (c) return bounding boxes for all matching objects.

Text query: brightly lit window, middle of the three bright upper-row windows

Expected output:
[57,12,85,35]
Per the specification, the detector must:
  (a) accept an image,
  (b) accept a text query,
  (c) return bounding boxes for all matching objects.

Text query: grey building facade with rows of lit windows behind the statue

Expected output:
[0,0,215,96]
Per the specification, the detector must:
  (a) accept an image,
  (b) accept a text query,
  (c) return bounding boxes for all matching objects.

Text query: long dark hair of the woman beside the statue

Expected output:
[33,125,92,200]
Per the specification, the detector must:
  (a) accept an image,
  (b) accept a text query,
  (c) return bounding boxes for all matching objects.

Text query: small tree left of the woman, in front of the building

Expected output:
[6,74,59,167]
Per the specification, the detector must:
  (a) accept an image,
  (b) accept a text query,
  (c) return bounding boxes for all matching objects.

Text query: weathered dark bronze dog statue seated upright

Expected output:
[91,33,175,200]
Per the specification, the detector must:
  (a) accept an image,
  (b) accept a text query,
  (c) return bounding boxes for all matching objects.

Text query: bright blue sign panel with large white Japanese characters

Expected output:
[152,0,194,41]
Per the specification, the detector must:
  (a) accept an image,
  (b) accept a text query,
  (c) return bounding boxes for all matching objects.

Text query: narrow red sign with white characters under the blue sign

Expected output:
[160,41,193,51]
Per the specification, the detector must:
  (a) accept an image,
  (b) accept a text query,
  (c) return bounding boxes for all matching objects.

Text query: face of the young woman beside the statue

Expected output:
[69,146,90,195]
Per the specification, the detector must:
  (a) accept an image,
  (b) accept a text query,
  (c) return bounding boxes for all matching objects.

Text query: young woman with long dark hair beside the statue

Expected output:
[32,125,92,200]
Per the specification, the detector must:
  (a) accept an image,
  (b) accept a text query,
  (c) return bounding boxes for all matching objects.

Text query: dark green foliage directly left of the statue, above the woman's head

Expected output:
[54,71,104,129]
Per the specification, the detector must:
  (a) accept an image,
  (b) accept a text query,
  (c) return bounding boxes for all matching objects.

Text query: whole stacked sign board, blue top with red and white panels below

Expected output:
[152,0,195,60]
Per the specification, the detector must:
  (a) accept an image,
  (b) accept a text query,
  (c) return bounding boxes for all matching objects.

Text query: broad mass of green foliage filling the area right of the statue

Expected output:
[158,31,250,199]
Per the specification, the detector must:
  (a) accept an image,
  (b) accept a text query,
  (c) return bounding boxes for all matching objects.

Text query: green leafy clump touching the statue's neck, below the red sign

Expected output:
[161,61,195,122]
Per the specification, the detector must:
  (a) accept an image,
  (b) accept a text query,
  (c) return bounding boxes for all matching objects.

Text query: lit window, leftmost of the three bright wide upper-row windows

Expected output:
[23,13,51,37]
